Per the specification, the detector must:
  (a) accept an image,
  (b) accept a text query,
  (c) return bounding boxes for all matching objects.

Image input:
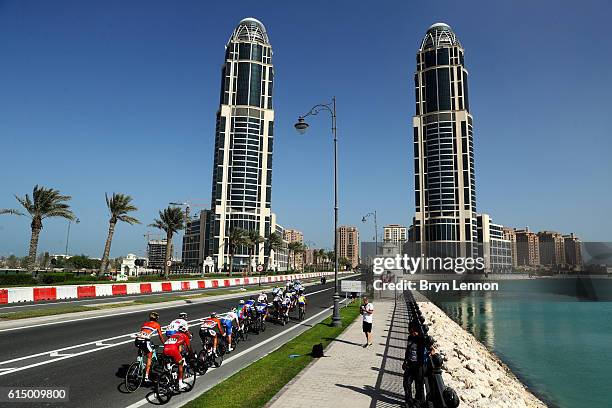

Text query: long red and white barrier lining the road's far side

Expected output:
[0,272,333,304]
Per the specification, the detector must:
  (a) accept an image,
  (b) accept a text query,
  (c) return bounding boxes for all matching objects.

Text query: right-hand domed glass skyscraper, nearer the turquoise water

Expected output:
[412,23,477,256]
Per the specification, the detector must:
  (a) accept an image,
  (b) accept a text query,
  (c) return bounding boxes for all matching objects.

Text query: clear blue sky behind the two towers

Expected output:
[0,0,612,256]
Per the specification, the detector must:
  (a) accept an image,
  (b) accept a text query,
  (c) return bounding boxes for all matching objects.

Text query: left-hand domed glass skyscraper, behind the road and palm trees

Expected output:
[204,18,274,269]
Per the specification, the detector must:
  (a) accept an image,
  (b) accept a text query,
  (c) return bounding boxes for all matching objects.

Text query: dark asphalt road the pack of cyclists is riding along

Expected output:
[0,283,358,408]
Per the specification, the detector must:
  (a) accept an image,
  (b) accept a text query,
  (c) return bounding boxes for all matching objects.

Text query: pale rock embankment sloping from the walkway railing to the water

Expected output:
[419,302,546,408]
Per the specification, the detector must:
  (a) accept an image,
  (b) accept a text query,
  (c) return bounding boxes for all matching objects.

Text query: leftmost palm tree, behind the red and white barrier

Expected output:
[0,184,76,273]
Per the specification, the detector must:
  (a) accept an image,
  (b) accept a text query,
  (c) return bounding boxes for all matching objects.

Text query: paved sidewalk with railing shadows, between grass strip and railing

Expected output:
[267,298,408,408]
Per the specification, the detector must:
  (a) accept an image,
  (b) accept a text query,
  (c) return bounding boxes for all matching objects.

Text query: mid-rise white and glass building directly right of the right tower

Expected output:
[476,214,512,273]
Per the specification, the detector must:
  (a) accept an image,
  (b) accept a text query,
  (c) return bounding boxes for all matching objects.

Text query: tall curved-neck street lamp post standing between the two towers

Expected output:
[294,96,342,326]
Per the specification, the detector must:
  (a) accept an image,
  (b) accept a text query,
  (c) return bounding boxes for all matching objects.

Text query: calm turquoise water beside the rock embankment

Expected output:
[427,281,612,408]
